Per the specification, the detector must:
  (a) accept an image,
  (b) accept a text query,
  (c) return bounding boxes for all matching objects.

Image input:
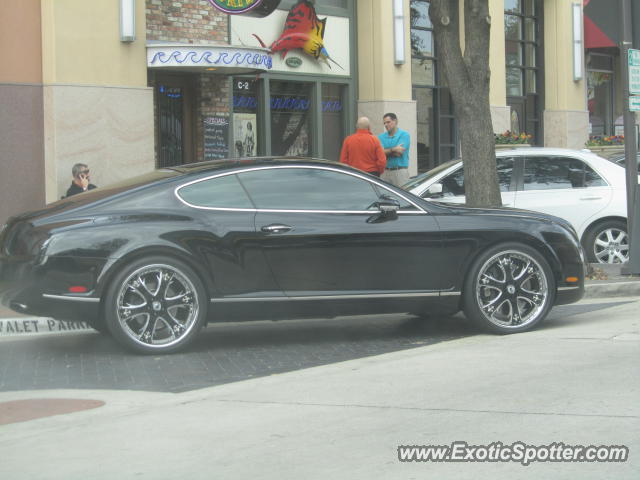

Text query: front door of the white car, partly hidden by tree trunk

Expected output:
[422,157,516,207]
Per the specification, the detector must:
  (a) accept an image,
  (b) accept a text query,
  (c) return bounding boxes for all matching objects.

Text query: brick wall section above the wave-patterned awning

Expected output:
[146,0,229,43]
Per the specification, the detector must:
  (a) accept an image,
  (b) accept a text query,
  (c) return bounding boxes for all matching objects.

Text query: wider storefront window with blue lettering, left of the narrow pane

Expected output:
[270,81,312,156]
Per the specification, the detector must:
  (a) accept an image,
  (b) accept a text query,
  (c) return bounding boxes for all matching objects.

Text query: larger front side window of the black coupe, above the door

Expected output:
[239,168,378,211]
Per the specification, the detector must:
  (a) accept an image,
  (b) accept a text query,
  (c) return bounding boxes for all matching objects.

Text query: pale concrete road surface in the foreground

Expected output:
[0,298,640,480]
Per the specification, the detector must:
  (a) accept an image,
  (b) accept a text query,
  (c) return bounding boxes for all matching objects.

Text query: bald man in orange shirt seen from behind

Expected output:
[340,117,387,177]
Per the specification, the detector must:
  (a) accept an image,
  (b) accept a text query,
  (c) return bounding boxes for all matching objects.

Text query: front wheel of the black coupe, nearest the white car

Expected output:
[462,243,556,334]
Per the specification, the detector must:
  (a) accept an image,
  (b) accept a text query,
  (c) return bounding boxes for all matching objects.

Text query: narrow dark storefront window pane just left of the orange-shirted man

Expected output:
[322,83,344,161]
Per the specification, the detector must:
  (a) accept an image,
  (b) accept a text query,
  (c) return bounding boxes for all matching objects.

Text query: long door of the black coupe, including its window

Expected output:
[239,167,441,297]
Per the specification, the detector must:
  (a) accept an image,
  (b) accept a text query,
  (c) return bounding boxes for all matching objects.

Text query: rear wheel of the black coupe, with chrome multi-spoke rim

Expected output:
[104,256,208,354]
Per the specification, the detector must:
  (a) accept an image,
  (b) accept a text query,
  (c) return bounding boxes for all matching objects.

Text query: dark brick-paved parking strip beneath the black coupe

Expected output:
[0,299,623,392]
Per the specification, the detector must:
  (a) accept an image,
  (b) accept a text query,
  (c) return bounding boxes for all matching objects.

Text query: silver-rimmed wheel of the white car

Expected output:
[582,220,629,263]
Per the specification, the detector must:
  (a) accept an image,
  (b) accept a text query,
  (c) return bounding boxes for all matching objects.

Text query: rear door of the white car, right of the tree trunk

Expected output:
[515,156,613,232]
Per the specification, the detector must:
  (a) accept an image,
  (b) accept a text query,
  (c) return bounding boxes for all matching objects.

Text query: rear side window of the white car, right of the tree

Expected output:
[524,157,606,190]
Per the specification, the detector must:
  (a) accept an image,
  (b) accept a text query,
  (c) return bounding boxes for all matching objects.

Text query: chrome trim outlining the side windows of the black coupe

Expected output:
[173,165,428,215]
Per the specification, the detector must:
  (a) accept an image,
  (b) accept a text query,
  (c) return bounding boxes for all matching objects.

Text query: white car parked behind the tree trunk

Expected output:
[404,147,629,263]
